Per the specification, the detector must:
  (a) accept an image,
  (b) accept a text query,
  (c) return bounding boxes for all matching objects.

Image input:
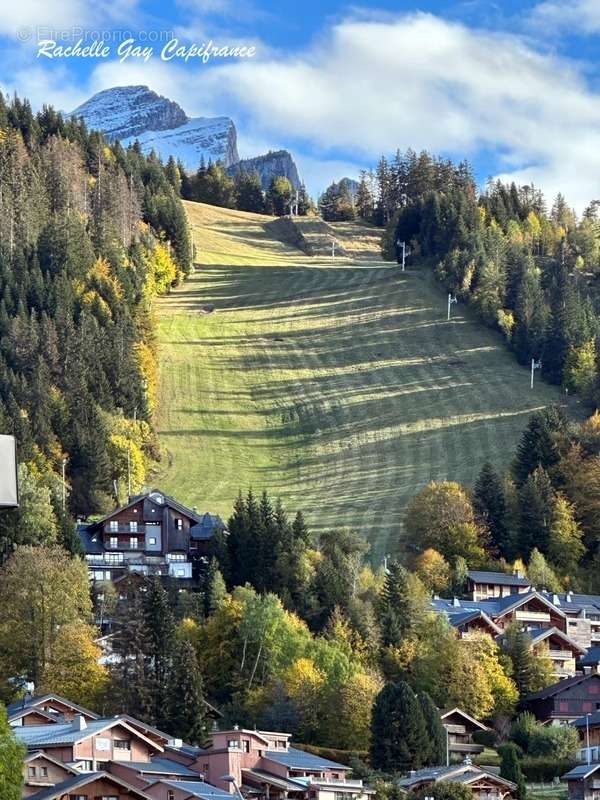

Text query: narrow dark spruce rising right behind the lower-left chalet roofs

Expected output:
[167,639,208,746]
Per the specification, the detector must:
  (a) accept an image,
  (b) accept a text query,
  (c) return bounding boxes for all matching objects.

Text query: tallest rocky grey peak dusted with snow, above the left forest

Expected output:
[72,86,239,167]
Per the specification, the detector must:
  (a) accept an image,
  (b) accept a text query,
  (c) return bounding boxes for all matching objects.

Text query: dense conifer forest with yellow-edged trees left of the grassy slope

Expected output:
[0,97,192,554]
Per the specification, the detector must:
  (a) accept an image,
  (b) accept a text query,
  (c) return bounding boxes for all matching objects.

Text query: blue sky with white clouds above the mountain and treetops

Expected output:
[0,0,600,209]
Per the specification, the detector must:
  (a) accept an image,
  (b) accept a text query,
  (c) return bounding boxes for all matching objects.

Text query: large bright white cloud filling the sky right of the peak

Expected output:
[180,14,600,207]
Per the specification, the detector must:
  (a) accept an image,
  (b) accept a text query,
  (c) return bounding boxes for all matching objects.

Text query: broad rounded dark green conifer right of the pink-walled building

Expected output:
[371,682,429,772]
